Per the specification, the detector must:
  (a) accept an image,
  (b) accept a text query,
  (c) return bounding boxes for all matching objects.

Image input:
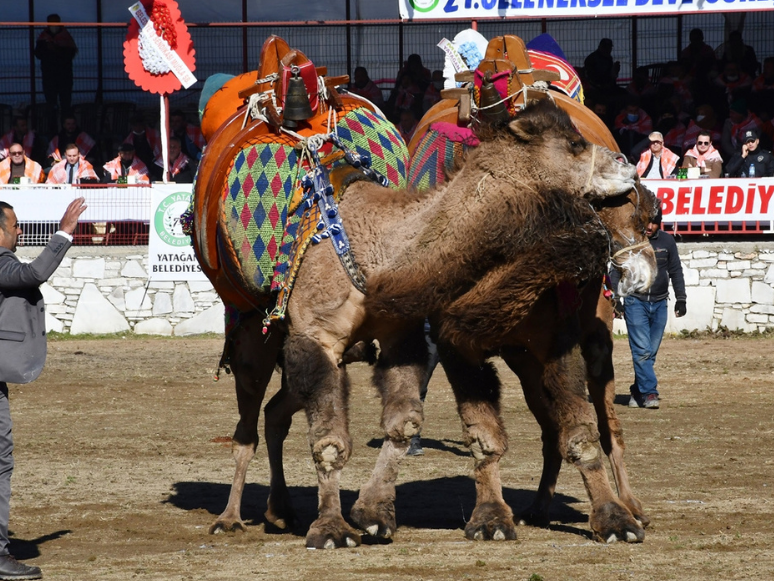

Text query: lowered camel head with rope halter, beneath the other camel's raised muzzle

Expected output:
[592,180,660,296]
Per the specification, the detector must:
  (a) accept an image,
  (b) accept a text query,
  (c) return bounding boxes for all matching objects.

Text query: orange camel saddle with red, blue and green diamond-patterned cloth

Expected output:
[188,36,408,326]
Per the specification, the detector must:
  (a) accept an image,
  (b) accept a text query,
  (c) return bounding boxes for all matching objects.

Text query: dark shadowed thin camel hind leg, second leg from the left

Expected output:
[263,374,303,531]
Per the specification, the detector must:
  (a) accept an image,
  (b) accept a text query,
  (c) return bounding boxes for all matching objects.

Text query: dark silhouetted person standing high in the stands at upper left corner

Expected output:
[35,14,78,133]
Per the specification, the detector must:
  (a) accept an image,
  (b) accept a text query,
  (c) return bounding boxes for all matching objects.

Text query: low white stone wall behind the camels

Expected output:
[17,241,774,336]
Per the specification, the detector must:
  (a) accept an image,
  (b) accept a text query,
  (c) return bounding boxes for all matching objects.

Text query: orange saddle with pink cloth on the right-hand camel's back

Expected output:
[408,31,618,190]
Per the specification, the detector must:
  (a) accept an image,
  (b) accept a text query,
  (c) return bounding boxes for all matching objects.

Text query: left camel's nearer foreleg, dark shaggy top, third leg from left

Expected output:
[284,334,360,549]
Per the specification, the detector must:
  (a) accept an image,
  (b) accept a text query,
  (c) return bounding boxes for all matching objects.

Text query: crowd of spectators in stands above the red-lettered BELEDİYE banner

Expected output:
[579,28,774,177]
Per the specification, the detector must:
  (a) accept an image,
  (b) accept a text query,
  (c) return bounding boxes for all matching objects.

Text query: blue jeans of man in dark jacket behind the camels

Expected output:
[624,297,668,397]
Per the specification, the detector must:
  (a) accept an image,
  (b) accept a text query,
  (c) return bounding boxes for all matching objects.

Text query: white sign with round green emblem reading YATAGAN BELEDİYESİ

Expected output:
[148,184,208,281]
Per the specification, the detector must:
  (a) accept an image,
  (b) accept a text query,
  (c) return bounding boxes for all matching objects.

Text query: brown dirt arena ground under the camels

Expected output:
[10,338,774,581]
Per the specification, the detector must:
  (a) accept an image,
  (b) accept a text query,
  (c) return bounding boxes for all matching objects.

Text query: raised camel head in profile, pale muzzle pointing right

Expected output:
[508,98,637,201]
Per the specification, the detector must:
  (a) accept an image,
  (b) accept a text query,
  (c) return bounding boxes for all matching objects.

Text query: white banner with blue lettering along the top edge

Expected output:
[398,0,774,20]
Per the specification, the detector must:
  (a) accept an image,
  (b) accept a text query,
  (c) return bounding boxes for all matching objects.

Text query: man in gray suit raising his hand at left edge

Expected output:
[0,198,86,579]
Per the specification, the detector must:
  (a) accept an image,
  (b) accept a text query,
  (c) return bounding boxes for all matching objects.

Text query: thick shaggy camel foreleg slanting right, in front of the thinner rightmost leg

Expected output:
[543,342,645,542]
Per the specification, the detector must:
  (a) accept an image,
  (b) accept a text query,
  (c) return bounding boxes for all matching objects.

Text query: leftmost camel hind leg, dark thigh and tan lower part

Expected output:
[209,321,284,533]
